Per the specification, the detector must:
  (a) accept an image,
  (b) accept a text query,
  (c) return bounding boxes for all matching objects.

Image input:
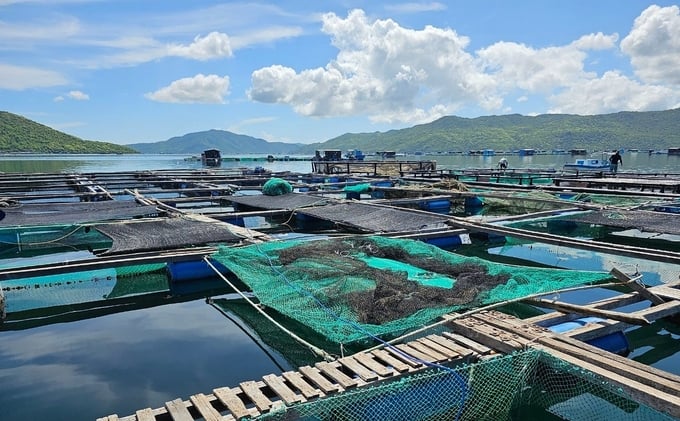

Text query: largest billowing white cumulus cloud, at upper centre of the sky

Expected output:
[249,10,500,123]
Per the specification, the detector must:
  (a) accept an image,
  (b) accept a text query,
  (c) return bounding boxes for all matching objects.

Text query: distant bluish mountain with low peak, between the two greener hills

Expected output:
[128,130,302,156]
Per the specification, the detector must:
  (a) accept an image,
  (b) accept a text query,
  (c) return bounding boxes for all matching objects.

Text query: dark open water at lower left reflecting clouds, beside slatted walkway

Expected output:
[0,300,280,420]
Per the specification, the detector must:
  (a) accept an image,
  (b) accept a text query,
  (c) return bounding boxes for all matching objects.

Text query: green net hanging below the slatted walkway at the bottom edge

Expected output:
[257,349,673,421]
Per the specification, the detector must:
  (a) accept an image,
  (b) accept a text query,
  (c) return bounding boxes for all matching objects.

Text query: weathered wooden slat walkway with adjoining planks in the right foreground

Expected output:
[98,283,680,421]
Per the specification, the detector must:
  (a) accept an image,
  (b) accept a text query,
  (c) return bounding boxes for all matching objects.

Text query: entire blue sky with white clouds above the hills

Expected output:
[0,0,680,144]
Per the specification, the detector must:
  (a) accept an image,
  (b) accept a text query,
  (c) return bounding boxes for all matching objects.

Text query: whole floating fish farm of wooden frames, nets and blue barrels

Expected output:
[0,161,680,421]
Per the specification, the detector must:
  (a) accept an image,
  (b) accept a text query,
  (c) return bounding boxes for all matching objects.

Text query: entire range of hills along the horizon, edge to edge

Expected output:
[0,108,680,156]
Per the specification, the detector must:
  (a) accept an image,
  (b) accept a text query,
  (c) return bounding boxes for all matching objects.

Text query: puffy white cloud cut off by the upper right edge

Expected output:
[621,5,680,85]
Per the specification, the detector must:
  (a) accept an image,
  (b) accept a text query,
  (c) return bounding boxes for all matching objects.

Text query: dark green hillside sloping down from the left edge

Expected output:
[0,111,136,154]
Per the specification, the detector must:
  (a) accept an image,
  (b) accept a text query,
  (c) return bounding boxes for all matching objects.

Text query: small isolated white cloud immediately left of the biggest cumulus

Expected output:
[144,74,229,104]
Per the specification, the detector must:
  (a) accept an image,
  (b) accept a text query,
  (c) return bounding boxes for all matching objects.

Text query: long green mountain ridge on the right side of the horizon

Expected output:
[297,108,680,154]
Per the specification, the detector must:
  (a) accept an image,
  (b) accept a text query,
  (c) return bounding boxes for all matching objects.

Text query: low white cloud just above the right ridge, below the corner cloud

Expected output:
[549,71,680,115]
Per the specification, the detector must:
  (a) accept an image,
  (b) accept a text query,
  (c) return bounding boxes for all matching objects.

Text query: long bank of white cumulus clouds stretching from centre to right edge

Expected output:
[248,7,680,123]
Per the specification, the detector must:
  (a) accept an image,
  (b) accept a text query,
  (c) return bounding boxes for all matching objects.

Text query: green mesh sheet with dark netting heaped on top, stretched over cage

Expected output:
[213,236,610,343]
